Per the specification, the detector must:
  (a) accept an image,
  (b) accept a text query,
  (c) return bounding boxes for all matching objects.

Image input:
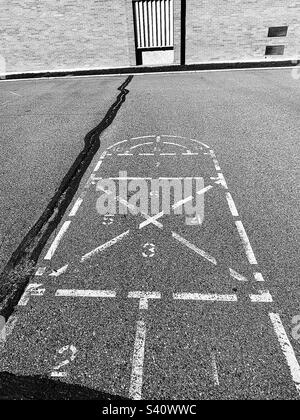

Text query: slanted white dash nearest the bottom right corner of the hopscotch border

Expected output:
[269,313,300,395]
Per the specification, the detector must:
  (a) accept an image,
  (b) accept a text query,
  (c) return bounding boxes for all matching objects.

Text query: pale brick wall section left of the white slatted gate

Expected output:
[0,0,134,72]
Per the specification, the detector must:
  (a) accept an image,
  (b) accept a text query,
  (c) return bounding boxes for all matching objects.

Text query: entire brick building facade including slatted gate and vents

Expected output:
[0,0,300,73]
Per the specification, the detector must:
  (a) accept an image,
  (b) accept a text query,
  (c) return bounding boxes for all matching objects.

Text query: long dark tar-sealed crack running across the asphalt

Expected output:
[0,76,133,319]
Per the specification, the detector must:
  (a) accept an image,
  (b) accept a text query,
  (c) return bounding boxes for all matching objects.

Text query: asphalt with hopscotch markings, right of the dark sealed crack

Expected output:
[0,69,300,400]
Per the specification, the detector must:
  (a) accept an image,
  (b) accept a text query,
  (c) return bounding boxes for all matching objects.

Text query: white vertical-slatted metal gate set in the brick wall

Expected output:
[134,0,174,64]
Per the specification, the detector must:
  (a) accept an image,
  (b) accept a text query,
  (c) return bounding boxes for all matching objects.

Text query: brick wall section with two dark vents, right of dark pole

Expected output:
[186,0,300,63]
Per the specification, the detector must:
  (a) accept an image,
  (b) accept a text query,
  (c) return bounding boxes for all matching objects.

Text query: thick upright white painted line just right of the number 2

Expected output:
[129,321,146,400]
